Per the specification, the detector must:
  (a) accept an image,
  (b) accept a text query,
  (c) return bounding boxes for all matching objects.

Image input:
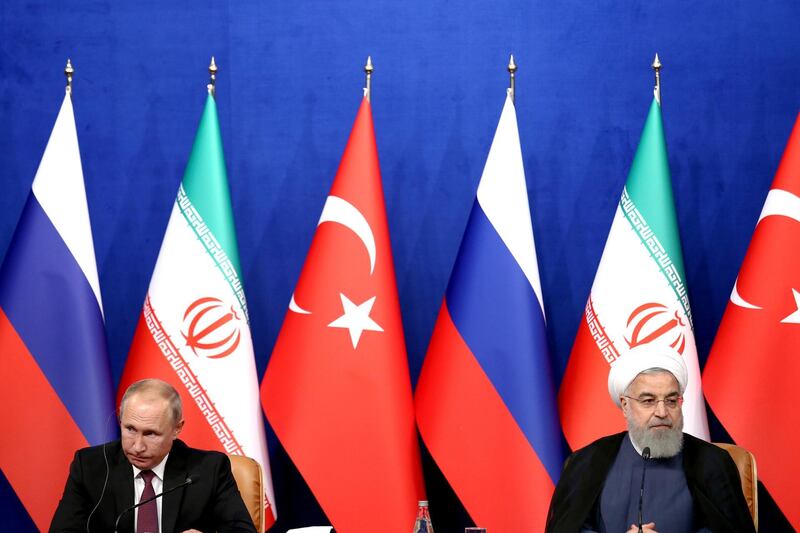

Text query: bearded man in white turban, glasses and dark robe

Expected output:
[547,344,755,533]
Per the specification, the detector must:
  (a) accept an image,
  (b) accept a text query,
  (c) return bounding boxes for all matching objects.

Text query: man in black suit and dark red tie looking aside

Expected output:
[50,379,256,533]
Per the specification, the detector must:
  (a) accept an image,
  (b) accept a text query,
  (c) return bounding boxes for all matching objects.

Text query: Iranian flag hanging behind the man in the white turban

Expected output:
[558,95,708,450]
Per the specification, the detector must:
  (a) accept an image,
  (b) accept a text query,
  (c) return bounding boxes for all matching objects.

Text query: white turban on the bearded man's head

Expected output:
[608,344,689,407]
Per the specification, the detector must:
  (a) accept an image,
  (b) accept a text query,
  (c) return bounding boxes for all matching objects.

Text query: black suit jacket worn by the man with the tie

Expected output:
[50,440,256,533]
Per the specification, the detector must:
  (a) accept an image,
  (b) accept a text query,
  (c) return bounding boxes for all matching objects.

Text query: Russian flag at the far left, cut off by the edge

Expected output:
[0,92,116,530]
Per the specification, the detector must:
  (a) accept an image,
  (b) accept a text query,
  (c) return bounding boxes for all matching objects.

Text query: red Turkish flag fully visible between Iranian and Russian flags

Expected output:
[261,98,423,533]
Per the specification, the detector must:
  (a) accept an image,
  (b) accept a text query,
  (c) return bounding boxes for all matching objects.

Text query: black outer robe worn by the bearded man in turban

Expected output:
[547,432,755,533]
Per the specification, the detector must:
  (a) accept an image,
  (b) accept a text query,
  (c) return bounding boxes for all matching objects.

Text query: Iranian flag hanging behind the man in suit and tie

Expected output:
[118,95,276,527]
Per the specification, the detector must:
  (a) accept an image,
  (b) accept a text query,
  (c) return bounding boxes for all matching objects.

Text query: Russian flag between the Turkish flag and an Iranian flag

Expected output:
[415,93,563,533]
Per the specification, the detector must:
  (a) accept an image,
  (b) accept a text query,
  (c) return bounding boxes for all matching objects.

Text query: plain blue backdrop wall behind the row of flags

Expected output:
[0,0,800,533]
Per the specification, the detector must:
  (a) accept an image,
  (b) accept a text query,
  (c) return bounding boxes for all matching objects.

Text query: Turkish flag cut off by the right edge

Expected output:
[703,110,800,529]
